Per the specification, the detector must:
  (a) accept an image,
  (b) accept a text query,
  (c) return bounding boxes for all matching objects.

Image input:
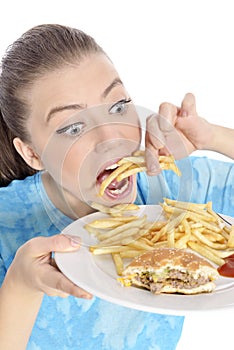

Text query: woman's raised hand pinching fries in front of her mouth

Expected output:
[145,93,212,175]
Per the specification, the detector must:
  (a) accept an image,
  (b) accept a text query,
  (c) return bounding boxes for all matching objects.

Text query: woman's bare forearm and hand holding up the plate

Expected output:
[0,235,91,350]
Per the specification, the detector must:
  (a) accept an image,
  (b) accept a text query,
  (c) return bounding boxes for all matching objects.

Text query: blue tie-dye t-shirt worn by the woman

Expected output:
[0,157,234,350]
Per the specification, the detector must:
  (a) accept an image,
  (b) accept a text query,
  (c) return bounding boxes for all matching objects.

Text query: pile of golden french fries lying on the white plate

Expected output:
[85,198,234,275]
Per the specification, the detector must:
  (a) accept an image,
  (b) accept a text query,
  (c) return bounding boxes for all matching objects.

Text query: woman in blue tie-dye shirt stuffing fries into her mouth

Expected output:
[0,25,234,350]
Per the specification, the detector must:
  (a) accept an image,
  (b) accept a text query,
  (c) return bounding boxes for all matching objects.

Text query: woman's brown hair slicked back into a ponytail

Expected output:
[0,24,104,187]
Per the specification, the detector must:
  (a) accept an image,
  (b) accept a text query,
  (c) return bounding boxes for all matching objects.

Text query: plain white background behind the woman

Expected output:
[0,0,234,350]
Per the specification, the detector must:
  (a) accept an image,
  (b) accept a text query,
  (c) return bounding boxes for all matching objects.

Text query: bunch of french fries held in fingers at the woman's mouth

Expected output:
[99,151,181,196]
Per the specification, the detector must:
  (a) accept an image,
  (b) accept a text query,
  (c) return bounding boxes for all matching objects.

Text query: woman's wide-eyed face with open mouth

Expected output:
[27,54,141,215]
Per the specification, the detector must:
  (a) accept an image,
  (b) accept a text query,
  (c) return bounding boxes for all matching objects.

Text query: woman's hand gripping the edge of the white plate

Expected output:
[7,234,92,299]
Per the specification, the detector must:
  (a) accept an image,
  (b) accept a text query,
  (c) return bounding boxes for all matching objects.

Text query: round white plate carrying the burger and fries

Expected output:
[55,205,234,315]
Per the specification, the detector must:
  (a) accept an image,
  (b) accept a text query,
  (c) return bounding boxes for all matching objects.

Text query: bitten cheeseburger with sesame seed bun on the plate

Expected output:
[118,248,219,294]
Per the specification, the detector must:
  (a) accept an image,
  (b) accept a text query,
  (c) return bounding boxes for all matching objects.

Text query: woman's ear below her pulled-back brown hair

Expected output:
[13,137,44,170]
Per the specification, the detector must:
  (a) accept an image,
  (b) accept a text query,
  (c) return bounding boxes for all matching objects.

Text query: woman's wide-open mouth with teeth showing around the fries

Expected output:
[97,163,132,198]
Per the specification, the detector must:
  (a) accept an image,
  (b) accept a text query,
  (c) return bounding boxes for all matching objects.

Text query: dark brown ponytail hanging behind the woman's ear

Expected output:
[0,110,36,187]
